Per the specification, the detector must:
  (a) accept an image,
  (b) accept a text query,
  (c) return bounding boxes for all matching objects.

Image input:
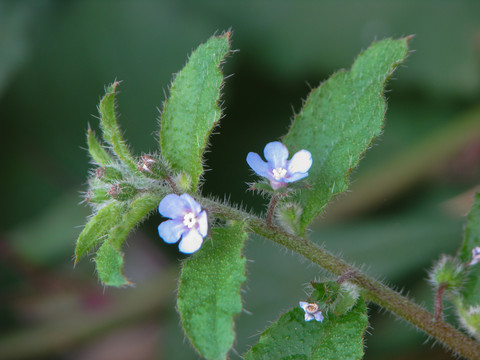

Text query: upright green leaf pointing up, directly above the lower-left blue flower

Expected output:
[160,32,230,190]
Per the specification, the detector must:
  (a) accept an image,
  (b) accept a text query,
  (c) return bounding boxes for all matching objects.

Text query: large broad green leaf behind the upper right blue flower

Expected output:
[283,38,408,231]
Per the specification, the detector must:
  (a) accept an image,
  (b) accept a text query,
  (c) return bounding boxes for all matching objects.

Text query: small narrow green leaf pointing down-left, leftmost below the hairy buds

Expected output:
[75,201,123,263]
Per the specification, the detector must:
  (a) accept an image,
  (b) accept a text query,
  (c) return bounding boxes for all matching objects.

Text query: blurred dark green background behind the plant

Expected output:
[0,0,480,360]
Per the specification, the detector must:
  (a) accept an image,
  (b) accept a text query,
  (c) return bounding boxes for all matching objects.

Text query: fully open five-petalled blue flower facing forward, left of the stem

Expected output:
[158,194,208,254]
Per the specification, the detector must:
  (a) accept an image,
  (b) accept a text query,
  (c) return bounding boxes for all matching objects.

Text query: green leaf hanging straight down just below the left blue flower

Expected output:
[177,223,247,360]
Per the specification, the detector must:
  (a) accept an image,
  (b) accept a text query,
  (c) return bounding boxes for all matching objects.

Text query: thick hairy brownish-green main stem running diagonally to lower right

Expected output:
[202,198,480,360]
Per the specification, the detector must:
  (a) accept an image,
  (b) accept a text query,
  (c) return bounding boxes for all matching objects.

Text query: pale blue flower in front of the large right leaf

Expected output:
[247,141,312,189]
